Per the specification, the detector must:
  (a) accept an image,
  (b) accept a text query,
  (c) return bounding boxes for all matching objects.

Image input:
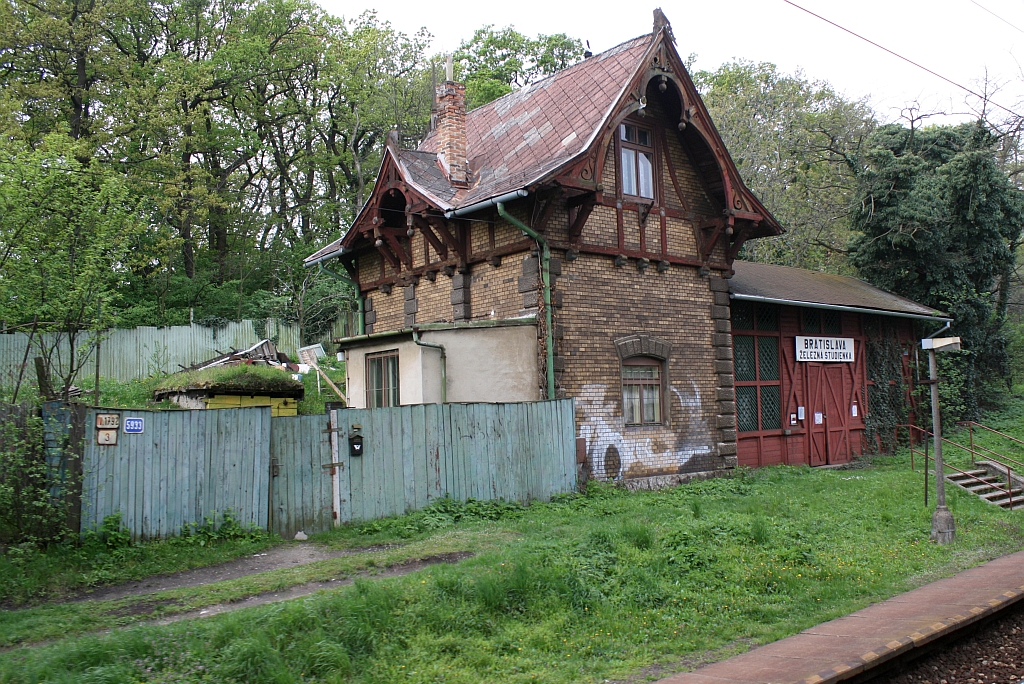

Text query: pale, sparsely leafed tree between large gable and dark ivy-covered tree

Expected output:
[693,60,876,272]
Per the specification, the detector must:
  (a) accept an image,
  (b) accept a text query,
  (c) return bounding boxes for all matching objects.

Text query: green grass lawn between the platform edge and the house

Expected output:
[0,446,1024,683]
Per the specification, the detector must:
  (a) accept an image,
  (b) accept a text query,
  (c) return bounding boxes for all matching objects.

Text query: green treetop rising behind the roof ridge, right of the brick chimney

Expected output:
[453,25,583,109]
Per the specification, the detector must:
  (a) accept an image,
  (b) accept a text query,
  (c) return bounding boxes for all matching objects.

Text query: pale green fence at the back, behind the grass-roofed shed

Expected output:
[0,314,354,384]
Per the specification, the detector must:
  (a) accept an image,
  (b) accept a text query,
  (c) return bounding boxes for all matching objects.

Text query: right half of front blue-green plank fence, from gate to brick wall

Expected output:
[270,399,575,539]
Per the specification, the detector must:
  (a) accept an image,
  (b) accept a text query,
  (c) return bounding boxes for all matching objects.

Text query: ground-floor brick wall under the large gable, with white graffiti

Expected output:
[555,248,735,479]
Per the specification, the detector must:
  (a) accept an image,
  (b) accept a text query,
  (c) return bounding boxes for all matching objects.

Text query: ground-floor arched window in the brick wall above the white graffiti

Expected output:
[615,335,670,425]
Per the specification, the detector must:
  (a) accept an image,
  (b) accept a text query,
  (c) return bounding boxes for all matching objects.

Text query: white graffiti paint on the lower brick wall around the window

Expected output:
[577,381,713,480]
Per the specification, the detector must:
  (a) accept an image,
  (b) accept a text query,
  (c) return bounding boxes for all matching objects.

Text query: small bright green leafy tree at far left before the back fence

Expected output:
[0,133,146,398]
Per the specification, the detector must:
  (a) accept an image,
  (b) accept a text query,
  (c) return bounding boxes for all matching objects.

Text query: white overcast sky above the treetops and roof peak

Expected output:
[318,0,1024,123]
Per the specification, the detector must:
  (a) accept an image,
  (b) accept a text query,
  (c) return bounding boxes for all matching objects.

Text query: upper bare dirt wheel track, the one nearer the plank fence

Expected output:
[69,542,397,603]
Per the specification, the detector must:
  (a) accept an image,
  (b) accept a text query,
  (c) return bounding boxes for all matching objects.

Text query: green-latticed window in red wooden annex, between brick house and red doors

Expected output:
[732,301,782,432]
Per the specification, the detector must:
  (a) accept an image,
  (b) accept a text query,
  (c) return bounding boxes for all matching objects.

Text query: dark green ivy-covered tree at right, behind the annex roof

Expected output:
[851,123,1024,420]
